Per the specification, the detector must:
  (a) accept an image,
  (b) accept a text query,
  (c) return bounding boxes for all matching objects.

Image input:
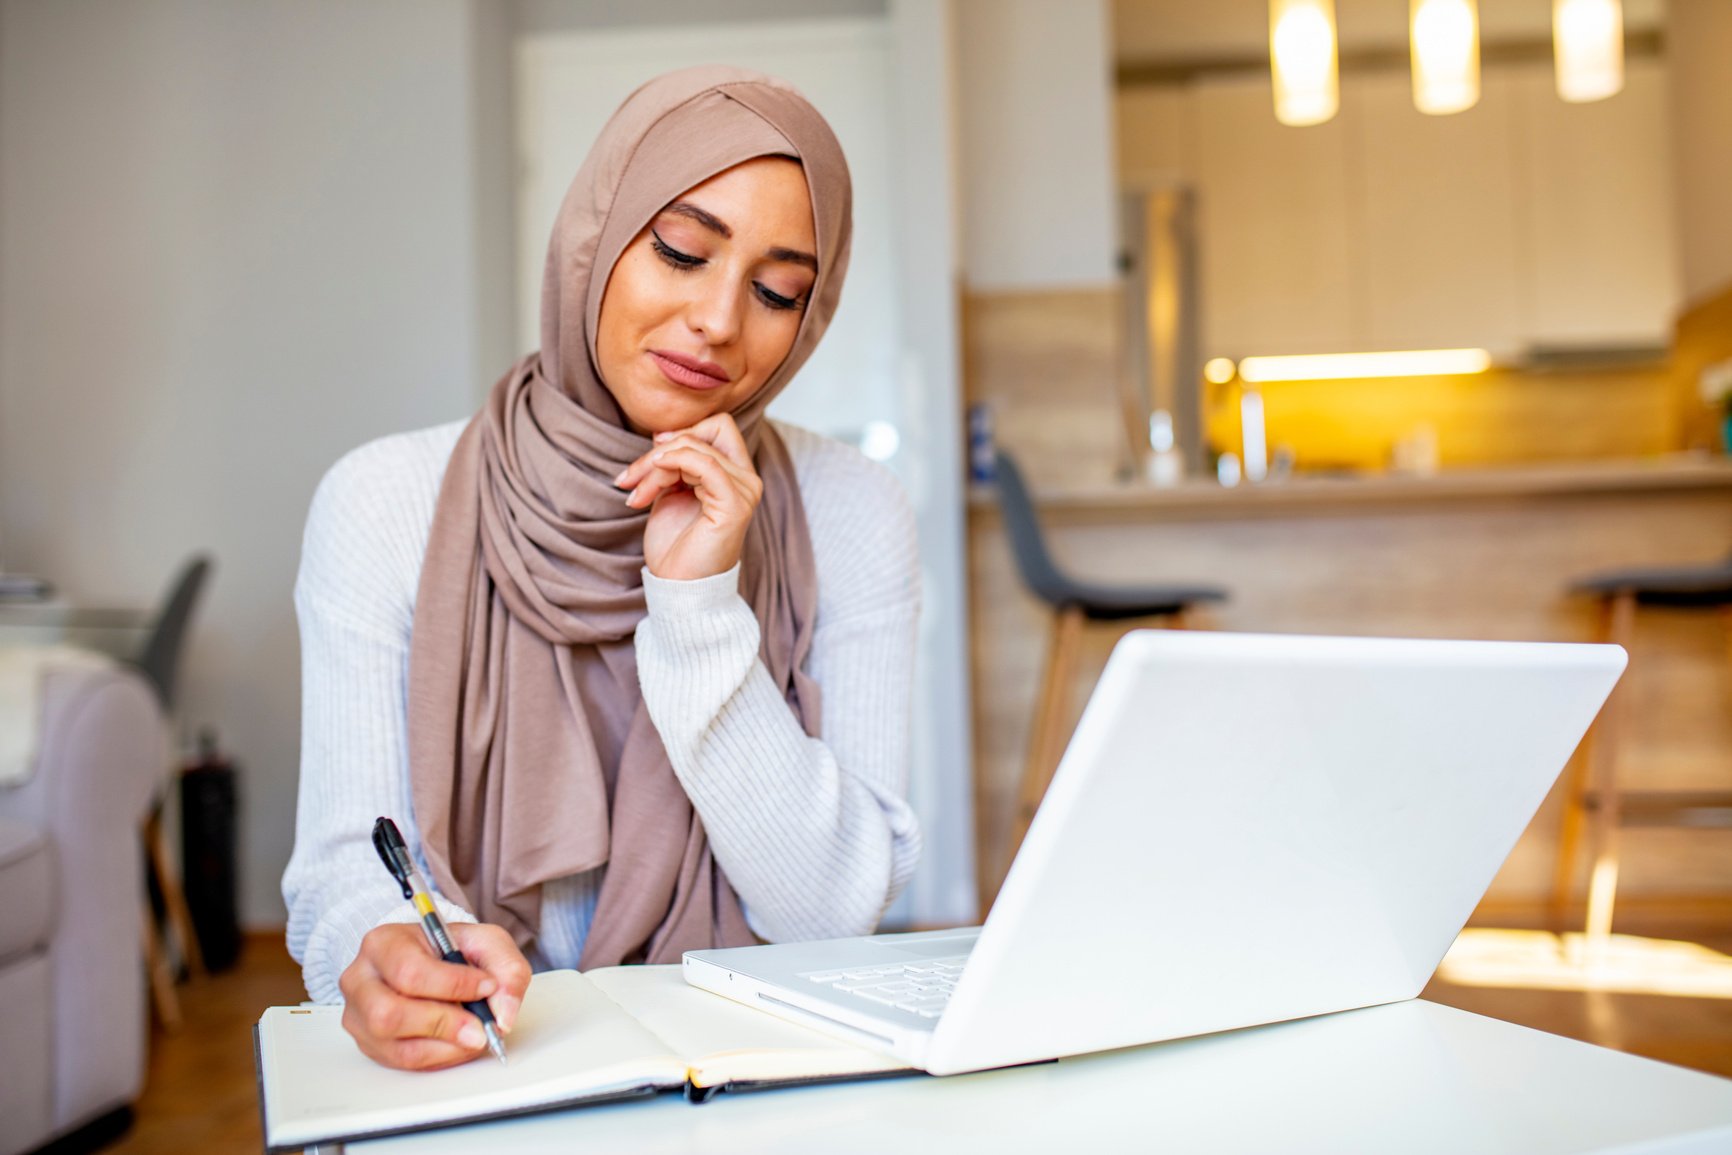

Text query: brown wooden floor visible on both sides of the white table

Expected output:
[104,918,1732,1155]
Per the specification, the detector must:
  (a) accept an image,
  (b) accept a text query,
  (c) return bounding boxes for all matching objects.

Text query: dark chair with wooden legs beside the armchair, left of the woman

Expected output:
[132,554,211,1030]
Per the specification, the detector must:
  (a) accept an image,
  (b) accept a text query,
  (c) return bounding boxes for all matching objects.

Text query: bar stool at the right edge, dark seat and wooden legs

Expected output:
[1552,558,1732,945]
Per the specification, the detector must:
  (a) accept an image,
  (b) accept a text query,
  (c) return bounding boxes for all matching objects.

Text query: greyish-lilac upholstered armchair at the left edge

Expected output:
[0,667,168,1155]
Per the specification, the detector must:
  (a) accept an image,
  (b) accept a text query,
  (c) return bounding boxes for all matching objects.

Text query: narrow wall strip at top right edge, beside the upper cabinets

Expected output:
[1666,0,1732,303]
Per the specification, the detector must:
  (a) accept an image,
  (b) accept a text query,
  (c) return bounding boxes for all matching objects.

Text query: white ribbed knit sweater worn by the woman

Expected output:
[282,423,920,1003]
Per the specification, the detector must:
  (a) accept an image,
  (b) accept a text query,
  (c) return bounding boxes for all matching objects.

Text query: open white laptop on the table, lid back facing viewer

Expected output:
[684,630,1625,1075]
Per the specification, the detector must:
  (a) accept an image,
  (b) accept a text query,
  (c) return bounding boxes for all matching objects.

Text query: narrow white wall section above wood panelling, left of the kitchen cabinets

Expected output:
[954,0,1117,289]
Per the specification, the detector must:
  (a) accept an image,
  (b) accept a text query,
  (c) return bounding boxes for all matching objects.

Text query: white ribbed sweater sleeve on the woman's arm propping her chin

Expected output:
[637,429,920,942]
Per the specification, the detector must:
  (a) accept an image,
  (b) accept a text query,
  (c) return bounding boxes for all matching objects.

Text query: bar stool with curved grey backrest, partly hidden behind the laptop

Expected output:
[996,452,1226,869]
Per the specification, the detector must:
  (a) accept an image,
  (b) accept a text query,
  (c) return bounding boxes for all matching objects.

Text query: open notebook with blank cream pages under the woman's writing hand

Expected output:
[253,966,909,1152]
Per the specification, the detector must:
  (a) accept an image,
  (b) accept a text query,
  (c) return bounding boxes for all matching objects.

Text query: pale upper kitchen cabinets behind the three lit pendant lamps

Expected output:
[1119,59,1678,358]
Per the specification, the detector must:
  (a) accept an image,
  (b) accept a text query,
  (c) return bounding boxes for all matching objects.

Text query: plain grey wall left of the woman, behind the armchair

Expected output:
[0,0,509,925]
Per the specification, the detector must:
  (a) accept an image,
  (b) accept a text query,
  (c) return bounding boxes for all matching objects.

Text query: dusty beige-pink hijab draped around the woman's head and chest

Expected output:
[409,68,850,970]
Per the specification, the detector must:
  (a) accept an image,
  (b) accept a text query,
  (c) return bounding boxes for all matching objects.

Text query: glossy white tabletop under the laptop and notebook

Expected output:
[330,999,1732,1155]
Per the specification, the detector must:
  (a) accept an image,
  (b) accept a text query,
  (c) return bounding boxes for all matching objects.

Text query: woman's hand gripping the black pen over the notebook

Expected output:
[338,923,530,1070]
